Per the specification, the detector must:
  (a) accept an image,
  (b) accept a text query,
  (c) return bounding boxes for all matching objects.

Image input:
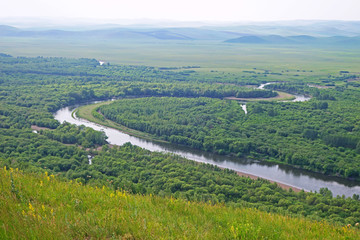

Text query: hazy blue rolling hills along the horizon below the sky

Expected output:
[0,21,360,46]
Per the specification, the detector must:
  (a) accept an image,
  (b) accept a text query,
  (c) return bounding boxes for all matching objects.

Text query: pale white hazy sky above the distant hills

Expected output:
[0,0,360,21]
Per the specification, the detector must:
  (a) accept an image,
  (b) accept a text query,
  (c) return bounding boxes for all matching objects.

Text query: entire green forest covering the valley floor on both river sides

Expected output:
[0,54,360,232]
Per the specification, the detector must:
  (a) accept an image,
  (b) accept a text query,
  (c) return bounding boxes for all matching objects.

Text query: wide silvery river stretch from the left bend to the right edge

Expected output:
[54,93,360,197]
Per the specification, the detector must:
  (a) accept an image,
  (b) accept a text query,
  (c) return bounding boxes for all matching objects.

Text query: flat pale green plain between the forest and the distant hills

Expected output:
[0,37,360,74]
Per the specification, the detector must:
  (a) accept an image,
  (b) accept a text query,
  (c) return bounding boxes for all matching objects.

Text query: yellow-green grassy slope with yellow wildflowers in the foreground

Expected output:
[0,168,360,239]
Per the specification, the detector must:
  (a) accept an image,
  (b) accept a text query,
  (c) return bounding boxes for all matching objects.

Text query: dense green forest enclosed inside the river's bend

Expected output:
[98,94,360,179]
